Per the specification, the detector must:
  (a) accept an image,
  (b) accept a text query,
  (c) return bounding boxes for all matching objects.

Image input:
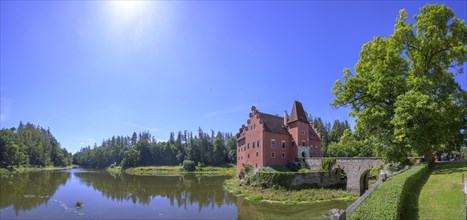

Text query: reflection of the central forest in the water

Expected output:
[74,172,234,212]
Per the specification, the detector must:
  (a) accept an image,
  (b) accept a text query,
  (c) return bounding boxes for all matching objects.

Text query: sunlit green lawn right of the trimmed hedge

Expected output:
[418,162,467,219]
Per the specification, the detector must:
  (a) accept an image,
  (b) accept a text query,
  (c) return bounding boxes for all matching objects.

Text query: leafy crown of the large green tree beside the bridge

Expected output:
[332,5,467,165]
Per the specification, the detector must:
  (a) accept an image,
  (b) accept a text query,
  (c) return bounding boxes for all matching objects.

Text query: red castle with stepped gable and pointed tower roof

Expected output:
[237,101,321,172]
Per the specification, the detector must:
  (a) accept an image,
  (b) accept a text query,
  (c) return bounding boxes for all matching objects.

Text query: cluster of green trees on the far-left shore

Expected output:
[0,122,72,168]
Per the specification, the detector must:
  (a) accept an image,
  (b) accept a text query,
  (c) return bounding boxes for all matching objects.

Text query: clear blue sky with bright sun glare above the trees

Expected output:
[0,1,467,152]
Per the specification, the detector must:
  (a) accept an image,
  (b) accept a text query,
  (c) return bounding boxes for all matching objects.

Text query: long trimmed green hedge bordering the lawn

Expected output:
[348,164,429,219]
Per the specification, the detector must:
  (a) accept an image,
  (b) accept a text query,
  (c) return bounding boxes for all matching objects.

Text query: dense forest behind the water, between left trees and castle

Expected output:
[73,128,236,169]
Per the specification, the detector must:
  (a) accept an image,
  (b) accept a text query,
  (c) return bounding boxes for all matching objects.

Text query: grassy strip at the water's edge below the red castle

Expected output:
[224,178,358,204]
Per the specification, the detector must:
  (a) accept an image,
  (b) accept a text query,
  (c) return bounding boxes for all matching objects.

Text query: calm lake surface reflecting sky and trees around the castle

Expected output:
[0,169,349,219]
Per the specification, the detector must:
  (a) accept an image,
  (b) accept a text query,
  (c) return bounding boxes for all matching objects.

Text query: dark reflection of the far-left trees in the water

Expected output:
[0,171,70,214]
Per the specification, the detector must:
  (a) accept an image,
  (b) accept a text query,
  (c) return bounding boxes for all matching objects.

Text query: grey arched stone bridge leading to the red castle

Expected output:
[305,157,383,195]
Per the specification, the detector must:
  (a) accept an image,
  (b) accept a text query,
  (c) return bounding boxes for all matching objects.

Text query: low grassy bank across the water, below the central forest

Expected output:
[107,165,236,176]
